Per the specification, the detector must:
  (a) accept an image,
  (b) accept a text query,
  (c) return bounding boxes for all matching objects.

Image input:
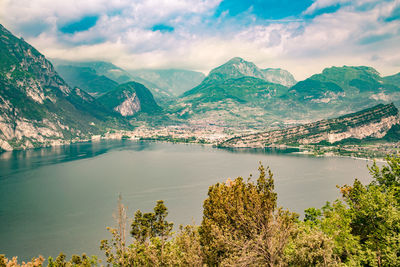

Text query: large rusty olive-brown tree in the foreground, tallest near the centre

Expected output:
[200,164,298,266]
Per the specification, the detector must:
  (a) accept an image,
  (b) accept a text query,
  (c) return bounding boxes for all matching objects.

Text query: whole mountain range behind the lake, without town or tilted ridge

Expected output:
[0,25,400,150]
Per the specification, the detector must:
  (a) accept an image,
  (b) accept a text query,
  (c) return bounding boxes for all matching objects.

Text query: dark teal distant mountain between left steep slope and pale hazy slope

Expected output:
[56,65,118,96]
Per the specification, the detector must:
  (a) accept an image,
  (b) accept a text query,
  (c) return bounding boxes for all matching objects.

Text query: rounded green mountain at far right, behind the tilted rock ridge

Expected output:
[264,66,400,123]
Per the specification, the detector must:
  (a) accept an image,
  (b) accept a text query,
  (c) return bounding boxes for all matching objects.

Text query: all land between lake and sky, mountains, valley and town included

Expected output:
[0,25,400,157]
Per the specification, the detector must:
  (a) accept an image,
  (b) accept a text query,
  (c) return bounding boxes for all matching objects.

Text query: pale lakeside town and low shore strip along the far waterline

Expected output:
[91,125,400,160]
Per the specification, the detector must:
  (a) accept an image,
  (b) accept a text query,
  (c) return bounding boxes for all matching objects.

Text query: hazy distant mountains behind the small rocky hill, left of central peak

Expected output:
[52,59,205,105]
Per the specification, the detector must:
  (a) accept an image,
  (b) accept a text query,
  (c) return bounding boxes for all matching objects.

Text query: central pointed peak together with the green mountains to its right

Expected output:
[172,58,400,128]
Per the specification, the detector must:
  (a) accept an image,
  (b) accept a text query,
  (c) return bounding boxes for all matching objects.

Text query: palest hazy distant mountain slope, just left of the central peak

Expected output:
[130,69,205,96]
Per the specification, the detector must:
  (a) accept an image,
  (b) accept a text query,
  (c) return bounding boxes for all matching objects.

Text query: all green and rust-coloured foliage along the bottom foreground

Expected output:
[0,157,400,267]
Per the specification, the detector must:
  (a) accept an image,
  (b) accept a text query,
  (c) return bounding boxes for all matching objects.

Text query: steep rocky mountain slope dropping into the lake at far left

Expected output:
[0,25,127,150]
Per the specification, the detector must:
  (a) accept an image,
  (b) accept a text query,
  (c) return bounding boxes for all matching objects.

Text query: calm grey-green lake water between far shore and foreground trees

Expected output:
[0,140,376,260]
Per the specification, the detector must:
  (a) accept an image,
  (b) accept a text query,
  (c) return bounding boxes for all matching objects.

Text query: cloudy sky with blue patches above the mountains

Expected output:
[0,0,400,80]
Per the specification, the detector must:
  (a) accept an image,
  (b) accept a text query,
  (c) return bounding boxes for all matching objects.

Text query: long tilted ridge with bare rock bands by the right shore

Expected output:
[220,104,400,147]
